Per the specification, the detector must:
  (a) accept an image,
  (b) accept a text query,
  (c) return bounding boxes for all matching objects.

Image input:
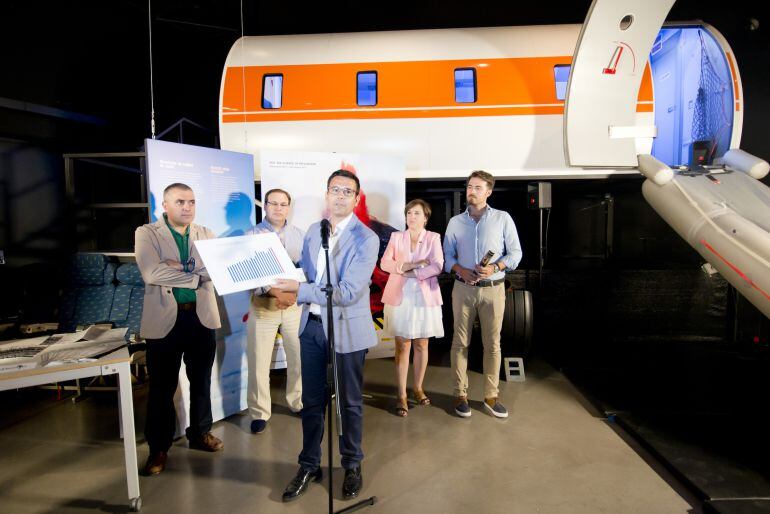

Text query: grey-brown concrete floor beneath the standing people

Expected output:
[0,360,700,514]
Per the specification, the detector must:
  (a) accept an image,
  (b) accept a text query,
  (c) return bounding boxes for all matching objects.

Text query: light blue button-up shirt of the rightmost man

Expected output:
[444,205,522,280]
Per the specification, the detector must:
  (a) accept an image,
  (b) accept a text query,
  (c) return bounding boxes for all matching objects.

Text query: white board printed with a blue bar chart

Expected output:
[195,232,305,295]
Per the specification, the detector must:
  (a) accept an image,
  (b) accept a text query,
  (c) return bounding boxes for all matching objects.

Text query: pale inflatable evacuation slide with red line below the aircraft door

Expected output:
[639,156,770,317]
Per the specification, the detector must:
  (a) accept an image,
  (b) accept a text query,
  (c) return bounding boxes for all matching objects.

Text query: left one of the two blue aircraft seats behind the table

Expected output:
[59,253,115,332]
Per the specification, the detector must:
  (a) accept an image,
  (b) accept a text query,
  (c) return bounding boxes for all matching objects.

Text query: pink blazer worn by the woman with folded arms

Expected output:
[380,230,444,307]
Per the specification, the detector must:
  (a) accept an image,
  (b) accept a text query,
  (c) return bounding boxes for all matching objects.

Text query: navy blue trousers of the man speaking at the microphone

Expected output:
[299,318,366,472]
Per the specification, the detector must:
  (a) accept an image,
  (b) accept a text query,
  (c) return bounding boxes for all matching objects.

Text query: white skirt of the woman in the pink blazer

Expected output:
[384,278,444,339]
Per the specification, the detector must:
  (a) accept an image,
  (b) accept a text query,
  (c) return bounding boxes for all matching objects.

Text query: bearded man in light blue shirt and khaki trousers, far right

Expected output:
[444,171,522,418]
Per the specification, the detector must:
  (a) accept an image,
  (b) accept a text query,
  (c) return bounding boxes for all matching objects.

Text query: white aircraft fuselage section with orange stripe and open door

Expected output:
[219,0,743,180]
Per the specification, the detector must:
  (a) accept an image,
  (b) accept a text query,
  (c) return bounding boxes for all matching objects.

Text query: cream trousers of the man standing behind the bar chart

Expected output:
[246,296,302,421]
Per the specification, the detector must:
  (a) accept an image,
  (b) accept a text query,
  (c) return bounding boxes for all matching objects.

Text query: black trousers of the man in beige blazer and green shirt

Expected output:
[144,309,217,453]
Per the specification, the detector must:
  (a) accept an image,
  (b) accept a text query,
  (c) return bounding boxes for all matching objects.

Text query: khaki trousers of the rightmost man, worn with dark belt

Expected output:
[450,281,505,398]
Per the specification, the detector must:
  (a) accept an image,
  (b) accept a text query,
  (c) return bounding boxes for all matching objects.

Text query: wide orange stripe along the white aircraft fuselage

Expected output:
[222,56,653,123]
